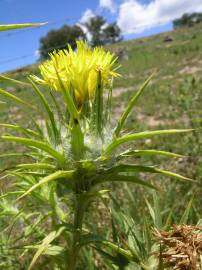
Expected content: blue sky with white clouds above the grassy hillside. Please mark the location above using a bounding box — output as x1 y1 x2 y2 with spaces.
0 0 202 72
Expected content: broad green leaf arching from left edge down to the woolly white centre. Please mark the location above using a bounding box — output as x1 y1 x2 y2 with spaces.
1 136 65 164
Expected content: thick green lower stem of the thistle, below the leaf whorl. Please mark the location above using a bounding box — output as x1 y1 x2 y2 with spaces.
67 194 87 270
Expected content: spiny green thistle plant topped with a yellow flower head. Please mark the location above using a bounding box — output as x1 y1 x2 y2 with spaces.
0 41 192 270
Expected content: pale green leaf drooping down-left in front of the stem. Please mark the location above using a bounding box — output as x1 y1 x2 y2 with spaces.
18 170 74 200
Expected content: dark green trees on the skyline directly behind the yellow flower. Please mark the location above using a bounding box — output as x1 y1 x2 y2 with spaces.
39 16 122 60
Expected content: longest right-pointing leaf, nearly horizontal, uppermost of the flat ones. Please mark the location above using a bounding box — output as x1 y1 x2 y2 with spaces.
103 129 193 156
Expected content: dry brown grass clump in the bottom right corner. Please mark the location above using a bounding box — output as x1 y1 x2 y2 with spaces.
154 225 202 270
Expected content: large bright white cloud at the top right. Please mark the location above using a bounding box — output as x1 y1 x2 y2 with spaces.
117 0 202 34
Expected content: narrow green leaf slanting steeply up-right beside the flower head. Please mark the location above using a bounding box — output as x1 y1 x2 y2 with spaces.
114 74 153 137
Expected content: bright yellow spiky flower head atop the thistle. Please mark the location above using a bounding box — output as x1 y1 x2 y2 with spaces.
34 41 119 107
